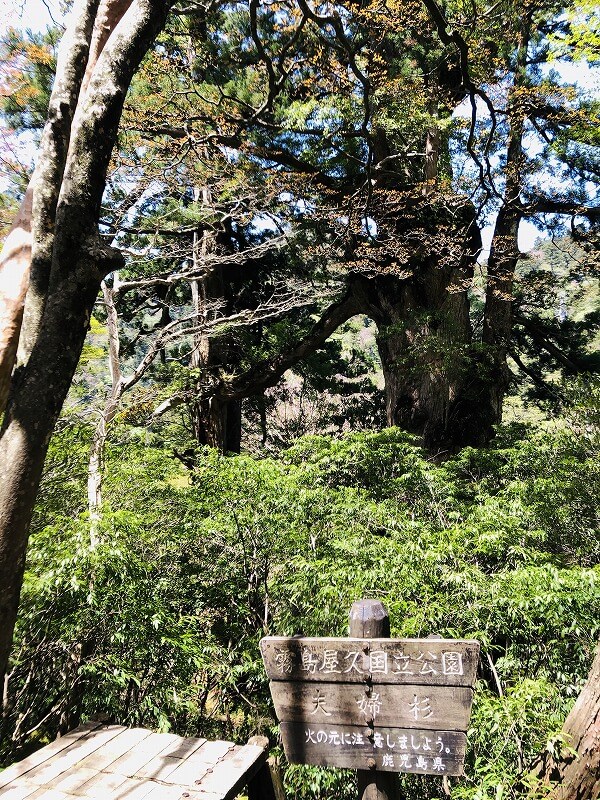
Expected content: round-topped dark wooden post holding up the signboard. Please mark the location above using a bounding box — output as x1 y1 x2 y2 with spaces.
349 600 400 800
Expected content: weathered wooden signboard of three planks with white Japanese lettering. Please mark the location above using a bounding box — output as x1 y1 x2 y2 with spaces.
260 637 479 775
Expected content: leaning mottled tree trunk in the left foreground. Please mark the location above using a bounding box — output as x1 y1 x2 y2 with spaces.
0 0 171 688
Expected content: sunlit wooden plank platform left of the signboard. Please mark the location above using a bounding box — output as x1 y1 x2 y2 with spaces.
0 723 272 800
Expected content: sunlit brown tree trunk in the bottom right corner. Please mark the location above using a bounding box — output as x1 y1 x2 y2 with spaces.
530 646 600 800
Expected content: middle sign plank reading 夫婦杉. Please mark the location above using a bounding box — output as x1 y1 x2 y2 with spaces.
270 681 473 731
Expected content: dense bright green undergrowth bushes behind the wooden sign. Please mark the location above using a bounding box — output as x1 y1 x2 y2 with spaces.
2 418 600 800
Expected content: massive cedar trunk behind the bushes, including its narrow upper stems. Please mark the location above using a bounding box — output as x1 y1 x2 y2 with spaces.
368 115 491 453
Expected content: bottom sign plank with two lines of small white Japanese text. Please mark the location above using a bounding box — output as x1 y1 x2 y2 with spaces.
281 722 467 775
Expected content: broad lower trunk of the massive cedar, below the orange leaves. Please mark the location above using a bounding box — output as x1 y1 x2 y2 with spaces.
358 266 482 452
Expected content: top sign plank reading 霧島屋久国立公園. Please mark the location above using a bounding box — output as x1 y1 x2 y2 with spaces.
260 636 479 686
